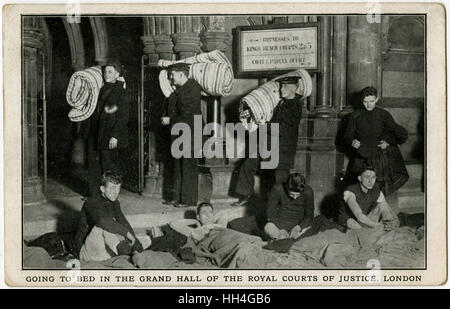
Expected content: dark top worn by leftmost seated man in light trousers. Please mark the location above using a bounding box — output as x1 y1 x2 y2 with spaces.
72 196 142 256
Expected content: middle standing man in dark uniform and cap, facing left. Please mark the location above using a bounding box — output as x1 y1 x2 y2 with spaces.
163 63 202 207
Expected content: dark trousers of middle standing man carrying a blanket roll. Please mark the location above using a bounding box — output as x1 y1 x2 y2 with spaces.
174 158 198 205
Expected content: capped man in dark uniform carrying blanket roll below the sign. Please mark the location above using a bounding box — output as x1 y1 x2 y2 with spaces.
232 76 303 206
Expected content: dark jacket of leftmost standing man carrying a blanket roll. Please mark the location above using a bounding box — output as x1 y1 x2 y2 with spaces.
97 81 130 150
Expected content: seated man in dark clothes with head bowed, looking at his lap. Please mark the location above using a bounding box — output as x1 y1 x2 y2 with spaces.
264 173 314 240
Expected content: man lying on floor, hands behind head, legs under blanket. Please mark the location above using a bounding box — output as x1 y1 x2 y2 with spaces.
169 203 265 268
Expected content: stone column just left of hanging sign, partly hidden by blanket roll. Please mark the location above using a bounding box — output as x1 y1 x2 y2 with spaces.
200 16 234 201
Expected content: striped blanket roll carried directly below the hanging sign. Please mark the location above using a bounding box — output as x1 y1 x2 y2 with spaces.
239 69 312 131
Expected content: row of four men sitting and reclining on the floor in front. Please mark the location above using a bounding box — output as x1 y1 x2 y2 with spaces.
72 162 399 261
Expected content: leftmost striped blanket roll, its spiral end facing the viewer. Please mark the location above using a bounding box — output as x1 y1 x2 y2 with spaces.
66 66 103 122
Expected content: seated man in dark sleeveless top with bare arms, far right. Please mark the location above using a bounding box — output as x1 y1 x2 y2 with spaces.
338 165 399 231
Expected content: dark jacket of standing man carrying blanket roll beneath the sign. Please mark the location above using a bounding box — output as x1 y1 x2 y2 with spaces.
270 95 303 169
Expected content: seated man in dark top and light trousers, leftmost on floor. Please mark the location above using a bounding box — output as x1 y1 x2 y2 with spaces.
73 171 143 261
